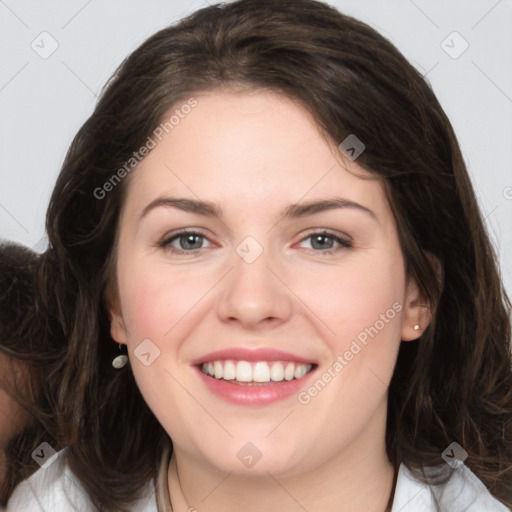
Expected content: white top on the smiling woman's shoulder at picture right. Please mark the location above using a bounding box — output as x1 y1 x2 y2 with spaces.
392 464 510 512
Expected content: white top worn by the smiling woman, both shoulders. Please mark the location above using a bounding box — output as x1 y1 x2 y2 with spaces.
7 450 511 512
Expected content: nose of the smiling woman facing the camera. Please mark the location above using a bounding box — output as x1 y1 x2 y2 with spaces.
217 241 293 330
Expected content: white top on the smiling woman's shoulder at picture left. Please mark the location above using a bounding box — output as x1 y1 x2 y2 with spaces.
6 449 157 512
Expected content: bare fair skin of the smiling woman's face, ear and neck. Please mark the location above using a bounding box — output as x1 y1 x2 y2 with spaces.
110 90 429 512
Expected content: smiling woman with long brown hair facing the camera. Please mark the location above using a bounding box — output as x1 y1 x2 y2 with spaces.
8 0 512 512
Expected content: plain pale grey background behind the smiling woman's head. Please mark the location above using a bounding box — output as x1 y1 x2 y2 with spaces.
0 0 512 295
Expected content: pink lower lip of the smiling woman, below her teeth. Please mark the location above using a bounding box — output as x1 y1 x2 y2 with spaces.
195 366 315 405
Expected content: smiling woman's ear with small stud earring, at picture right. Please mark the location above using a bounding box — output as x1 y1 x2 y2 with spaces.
401 253 443 341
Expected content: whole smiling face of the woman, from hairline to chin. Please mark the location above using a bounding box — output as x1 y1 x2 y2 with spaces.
111 91 424 475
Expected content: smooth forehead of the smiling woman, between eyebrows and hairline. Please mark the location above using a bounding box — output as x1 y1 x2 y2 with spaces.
119 90 387 222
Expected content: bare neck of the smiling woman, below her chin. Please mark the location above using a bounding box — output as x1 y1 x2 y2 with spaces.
168 400 395 512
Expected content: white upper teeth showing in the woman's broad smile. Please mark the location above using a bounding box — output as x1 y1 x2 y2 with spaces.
201 360 313 382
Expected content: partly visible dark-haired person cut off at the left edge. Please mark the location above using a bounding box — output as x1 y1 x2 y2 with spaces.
0 242 63 507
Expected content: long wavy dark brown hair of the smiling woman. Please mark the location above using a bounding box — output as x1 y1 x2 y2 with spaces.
40 0 512 511
